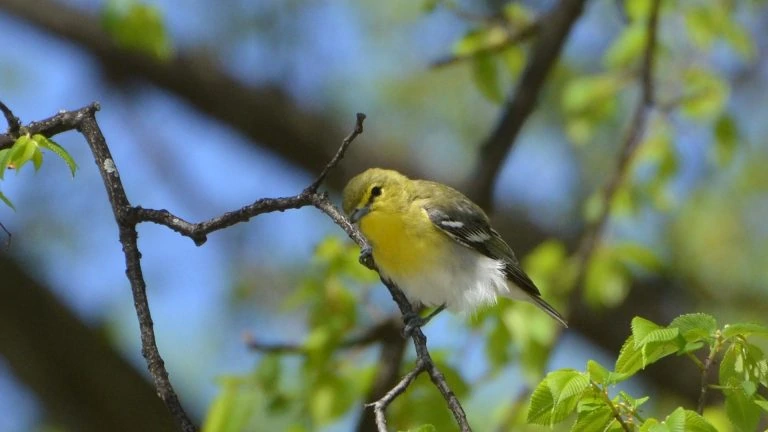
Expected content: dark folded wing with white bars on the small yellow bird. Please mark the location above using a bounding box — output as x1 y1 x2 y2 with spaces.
423 191 541 298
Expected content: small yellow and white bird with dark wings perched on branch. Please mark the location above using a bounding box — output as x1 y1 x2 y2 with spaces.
343 168 568 332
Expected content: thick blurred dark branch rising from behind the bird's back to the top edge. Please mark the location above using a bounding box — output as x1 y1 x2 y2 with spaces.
470 0 586 208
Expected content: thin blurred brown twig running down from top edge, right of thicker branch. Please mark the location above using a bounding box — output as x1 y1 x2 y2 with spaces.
574 0 660 287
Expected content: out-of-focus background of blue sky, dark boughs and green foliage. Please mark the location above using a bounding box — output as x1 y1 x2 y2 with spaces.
0 0 768 432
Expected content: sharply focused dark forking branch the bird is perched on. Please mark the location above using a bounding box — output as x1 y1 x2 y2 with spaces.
0 103 471 432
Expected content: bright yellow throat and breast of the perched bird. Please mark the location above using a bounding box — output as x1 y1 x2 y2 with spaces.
360 210 446 280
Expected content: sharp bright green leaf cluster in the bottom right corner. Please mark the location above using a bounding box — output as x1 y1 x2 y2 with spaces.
528 313 768 432
